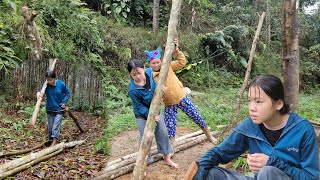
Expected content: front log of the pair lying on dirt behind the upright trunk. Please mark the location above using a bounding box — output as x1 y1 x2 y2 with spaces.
94 134 207 180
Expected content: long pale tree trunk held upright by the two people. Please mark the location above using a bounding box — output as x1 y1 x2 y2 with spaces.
131 0 181 180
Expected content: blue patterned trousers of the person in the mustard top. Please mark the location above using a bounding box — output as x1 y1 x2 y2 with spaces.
164 96 207 138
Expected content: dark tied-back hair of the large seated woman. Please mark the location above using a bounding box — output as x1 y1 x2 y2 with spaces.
248 74 289 114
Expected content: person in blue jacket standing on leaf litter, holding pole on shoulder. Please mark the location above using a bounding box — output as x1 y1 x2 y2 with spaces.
37 71 70 146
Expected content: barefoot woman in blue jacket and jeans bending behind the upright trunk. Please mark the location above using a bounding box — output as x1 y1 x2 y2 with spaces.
127 59 179 168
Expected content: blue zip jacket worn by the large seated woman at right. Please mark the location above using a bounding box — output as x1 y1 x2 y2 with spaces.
194 113 319 180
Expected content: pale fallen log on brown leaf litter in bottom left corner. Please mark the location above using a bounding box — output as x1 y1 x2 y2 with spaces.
0 141 84 176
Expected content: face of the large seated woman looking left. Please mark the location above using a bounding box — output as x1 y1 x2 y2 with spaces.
248 87 283 124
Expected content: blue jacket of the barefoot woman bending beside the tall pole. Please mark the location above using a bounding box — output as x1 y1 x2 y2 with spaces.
128 68 156 118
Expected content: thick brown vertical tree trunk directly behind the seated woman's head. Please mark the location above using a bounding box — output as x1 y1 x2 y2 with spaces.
282 0 300 111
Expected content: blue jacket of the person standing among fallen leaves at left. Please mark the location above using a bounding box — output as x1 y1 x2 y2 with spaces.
45 79 70 112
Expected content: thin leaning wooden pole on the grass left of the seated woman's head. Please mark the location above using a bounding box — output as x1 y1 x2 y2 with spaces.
221 12 266 135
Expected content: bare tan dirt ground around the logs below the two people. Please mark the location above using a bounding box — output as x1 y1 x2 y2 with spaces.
108 127 213 180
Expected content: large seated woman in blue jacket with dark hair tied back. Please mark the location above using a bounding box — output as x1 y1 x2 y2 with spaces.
194 75 319 180
